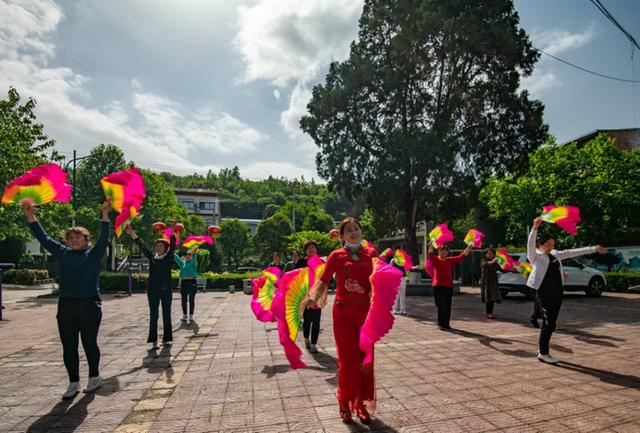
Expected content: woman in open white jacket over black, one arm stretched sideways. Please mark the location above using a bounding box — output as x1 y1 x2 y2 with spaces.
527 217 607 364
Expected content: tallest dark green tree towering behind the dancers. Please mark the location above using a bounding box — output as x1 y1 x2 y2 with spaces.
301 0 547 260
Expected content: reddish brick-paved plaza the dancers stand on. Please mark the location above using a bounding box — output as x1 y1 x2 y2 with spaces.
0 288 640 433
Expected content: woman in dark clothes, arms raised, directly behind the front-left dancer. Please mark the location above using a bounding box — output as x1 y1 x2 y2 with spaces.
127 221 176 349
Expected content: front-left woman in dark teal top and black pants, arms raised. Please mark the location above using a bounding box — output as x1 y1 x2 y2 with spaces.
20 199 111 400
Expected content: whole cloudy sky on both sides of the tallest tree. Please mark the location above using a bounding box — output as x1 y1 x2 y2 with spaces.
0 0 640 181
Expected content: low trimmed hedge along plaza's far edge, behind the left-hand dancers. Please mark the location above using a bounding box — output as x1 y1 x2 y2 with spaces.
100 272 260 293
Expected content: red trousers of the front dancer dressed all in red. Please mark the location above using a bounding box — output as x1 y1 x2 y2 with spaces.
333 303 376 414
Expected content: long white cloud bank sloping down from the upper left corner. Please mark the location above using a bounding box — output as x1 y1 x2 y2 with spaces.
0 0 266 176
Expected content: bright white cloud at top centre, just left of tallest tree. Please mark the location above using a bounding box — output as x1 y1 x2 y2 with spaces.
235 0 363 150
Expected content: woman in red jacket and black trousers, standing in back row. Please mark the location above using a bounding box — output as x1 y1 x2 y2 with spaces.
427 244 473 331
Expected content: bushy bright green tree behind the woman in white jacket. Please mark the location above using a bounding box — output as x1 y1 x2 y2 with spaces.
481 134 640 246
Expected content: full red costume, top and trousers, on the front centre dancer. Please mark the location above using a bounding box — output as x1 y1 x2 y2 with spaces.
321 247 378 413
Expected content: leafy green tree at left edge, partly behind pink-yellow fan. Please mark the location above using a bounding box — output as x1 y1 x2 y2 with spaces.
0 87 71 243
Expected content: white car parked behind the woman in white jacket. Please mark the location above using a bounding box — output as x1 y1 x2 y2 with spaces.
498 253 607 299
